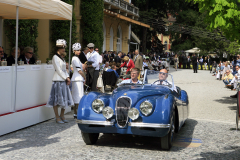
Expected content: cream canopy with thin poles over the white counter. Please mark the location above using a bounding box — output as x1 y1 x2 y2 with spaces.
0 0 72 111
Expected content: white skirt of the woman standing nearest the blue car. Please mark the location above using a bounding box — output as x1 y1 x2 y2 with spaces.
72 81 84 104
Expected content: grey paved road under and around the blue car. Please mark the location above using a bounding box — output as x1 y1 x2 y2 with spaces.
0 70 240 159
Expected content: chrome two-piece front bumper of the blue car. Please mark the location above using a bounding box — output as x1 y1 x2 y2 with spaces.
76 120 171 128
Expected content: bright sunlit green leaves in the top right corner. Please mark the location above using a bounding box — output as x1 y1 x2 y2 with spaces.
188 0 240 41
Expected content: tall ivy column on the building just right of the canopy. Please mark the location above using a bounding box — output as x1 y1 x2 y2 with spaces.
81 0 104 51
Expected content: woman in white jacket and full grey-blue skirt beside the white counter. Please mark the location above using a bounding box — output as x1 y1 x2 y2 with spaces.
46 39 74 124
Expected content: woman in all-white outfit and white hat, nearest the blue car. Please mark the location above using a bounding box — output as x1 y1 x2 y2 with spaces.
71 43 86 118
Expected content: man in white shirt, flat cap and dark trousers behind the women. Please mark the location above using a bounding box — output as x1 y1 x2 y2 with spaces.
87 43 99 91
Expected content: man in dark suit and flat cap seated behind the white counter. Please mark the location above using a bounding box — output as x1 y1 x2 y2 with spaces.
19 47 36 64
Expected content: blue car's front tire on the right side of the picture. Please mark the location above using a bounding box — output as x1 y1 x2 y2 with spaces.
161 112 175 150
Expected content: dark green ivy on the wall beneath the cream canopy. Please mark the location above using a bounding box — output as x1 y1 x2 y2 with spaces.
4 19 38 56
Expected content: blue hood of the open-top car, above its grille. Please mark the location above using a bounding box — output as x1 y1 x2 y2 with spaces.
112 85 171 105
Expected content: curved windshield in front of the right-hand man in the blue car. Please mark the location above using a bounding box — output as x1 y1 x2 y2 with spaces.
143 70 176 90
